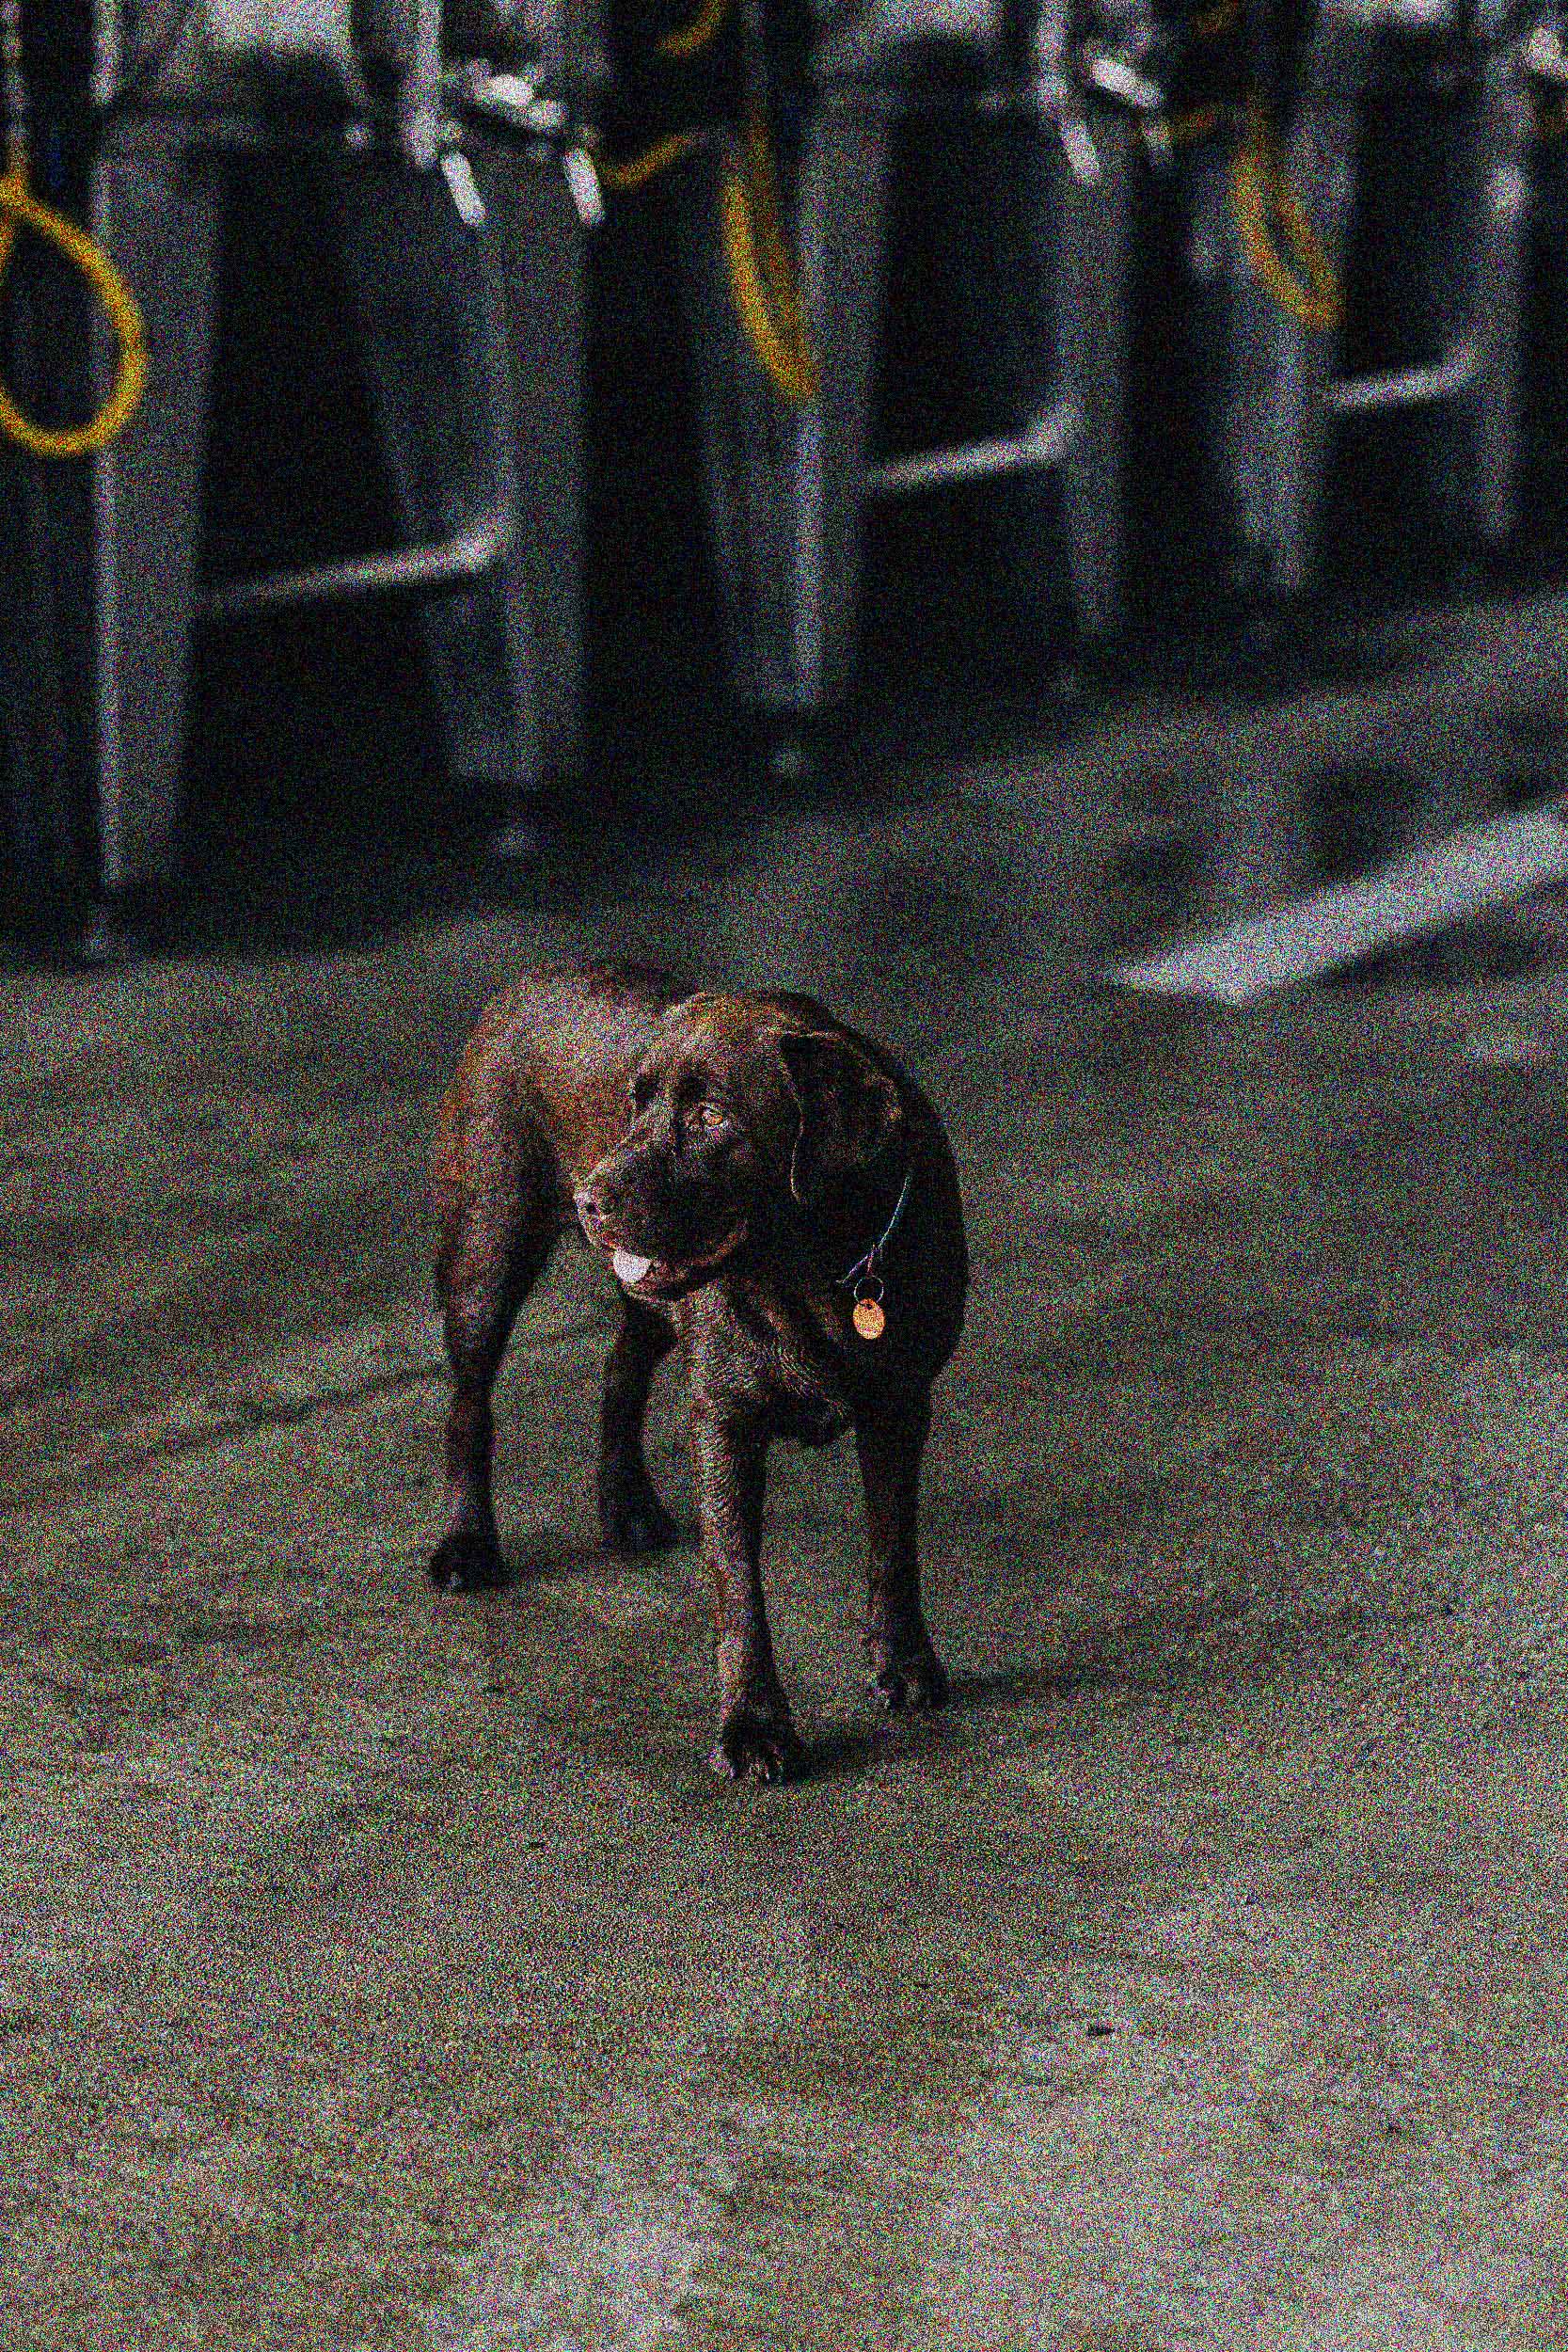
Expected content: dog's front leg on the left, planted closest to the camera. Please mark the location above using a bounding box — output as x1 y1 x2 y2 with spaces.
691 1400 801 1781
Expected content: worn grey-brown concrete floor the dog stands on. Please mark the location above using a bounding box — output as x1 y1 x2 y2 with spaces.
0 607 1568 2352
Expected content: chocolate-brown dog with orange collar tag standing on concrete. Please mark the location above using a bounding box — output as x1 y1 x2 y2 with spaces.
430 967 969 1781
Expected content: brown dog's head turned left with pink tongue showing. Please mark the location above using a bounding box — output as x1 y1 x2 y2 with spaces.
576 997 903 1298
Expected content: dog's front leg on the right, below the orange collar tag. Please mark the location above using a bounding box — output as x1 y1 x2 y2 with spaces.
856 1391 947 1712
